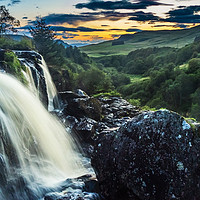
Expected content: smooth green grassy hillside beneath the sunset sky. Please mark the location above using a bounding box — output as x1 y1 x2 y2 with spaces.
81 26 200 57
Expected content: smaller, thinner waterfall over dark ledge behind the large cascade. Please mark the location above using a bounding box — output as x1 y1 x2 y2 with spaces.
14 51 59 111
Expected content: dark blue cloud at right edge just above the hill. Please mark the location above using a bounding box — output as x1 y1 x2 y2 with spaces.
162 5 200 23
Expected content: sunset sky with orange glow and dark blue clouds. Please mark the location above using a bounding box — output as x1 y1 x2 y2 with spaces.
0 0 200 46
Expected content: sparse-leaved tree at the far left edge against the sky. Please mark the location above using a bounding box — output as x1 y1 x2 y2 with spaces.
0 6 20 36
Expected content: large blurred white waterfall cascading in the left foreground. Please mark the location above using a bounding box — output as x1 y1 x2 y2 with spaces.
0 73 85 200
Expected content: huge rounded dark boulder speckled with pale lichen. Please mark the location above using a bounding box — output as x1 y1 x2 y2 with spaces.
92 110 200 200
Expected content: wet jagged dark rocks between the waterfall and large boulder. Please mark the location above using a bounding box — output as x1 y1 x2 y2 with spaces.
59 90 139 144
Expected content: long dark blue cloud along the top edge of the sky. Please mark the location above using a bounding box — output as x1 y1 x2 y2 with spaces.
75 0 169 10
